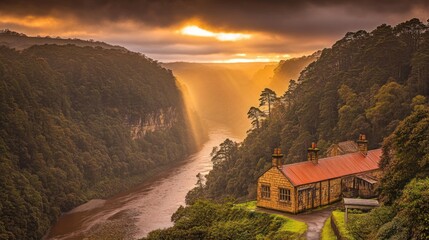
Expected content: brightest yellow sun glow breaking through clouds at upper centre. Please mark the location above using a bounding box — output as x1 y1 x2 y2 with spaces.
180 25 252 41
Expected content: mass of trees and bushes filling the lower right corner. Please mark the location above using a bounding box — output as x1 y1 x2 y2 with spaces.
349 104 429 239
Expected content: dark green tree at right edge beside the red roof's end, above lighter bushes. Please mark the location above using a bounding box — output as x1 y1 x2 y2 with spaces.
380 105 429 204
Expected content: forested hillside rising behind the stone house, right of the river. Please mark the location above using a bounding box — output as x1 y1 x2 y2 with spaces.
196 19 429 202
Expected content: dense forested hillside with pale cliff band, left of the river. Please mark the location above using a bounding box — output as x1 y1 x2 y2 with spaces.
0 45 196 239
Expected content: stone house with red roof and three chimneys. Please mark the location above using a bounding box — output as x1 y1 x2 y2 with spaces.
257 134 382 213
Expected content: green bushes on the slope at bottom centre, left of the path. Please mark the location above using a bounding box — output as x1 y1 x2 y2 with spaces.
143 201 306 240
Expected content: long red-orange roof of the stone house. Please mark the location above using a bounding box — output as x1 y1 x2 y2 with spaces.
280 149 381 186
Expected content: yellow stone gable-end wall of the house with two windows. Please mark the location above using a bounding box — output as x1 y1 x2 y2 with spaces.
256 167 296 213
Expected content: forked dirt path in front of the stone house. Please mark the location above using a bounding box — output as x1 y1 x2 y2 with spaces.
257 203 338 240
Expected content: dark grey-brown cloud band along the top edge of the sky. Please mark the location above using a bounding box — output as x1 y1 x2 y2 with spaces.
0 0 429 36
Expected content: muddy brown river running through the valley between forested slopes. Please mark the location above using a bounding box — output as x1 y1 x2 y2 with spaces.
47 128 239 239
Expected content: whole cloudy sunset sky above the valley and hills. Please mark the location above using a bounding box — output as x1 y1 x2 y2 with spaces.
0 0 429 62
